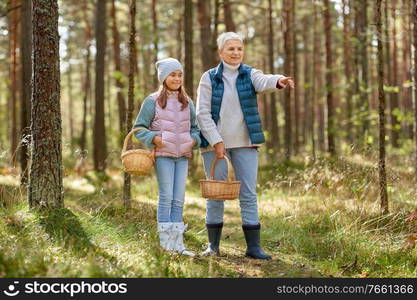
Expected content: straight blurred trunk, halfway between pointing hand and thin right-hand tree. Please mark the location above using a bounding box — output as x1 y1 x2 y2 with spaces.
323 0 336 156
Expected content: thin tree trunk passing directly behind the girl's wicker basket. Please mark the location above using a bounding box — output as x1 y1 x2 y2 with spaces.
123 0 136 208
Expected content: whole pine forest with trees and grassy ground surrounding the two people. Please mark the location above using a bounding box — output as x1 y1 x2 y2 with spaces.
0 0 417 278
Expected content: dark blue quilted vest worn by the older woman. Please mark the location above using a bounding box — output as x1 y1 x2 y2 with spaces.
200 63 265 148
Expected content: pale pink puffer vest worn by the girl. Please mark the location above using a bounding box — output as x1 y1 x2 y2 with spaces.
150 92 194 157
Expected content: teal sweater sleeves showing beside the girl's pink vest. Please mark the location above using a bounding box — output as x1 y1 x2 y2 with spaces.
132 97 201 149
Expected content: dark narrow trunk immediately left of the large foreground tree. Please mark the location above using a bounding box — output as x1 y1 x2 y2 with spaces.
20 1 32 184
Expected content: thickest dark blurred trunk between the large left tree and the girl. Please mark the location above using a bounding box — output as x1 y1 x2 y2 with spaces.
93 0 107 172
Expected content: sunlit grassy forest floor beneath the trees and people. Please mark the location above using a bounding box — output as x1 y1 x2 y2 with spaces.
0 156 417 278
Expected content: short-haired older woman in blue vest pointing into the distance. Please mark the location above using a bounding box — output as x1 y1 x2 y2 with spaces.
197 32 294 259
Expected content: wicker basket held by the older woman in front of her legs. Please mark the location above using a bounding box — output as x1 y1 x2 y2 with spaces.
200 156 240 200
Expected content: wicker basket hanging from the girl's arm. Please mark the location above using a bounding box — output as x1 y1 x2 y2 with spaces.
120 128 155 175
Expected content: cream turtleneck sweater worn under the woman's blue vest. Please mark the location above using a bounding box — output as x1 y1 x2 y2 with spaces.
197 62 283 149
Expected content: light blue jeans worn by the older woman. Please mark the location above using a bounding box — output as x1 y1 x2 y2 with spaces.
202 148 259 225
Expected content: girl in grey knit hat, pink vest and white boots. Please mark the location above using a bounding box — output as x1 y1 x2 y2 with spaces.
133 58 201 256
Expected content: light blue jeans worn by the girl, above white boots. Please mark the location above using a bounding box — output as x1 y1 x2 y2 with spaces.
155 157 188 223
